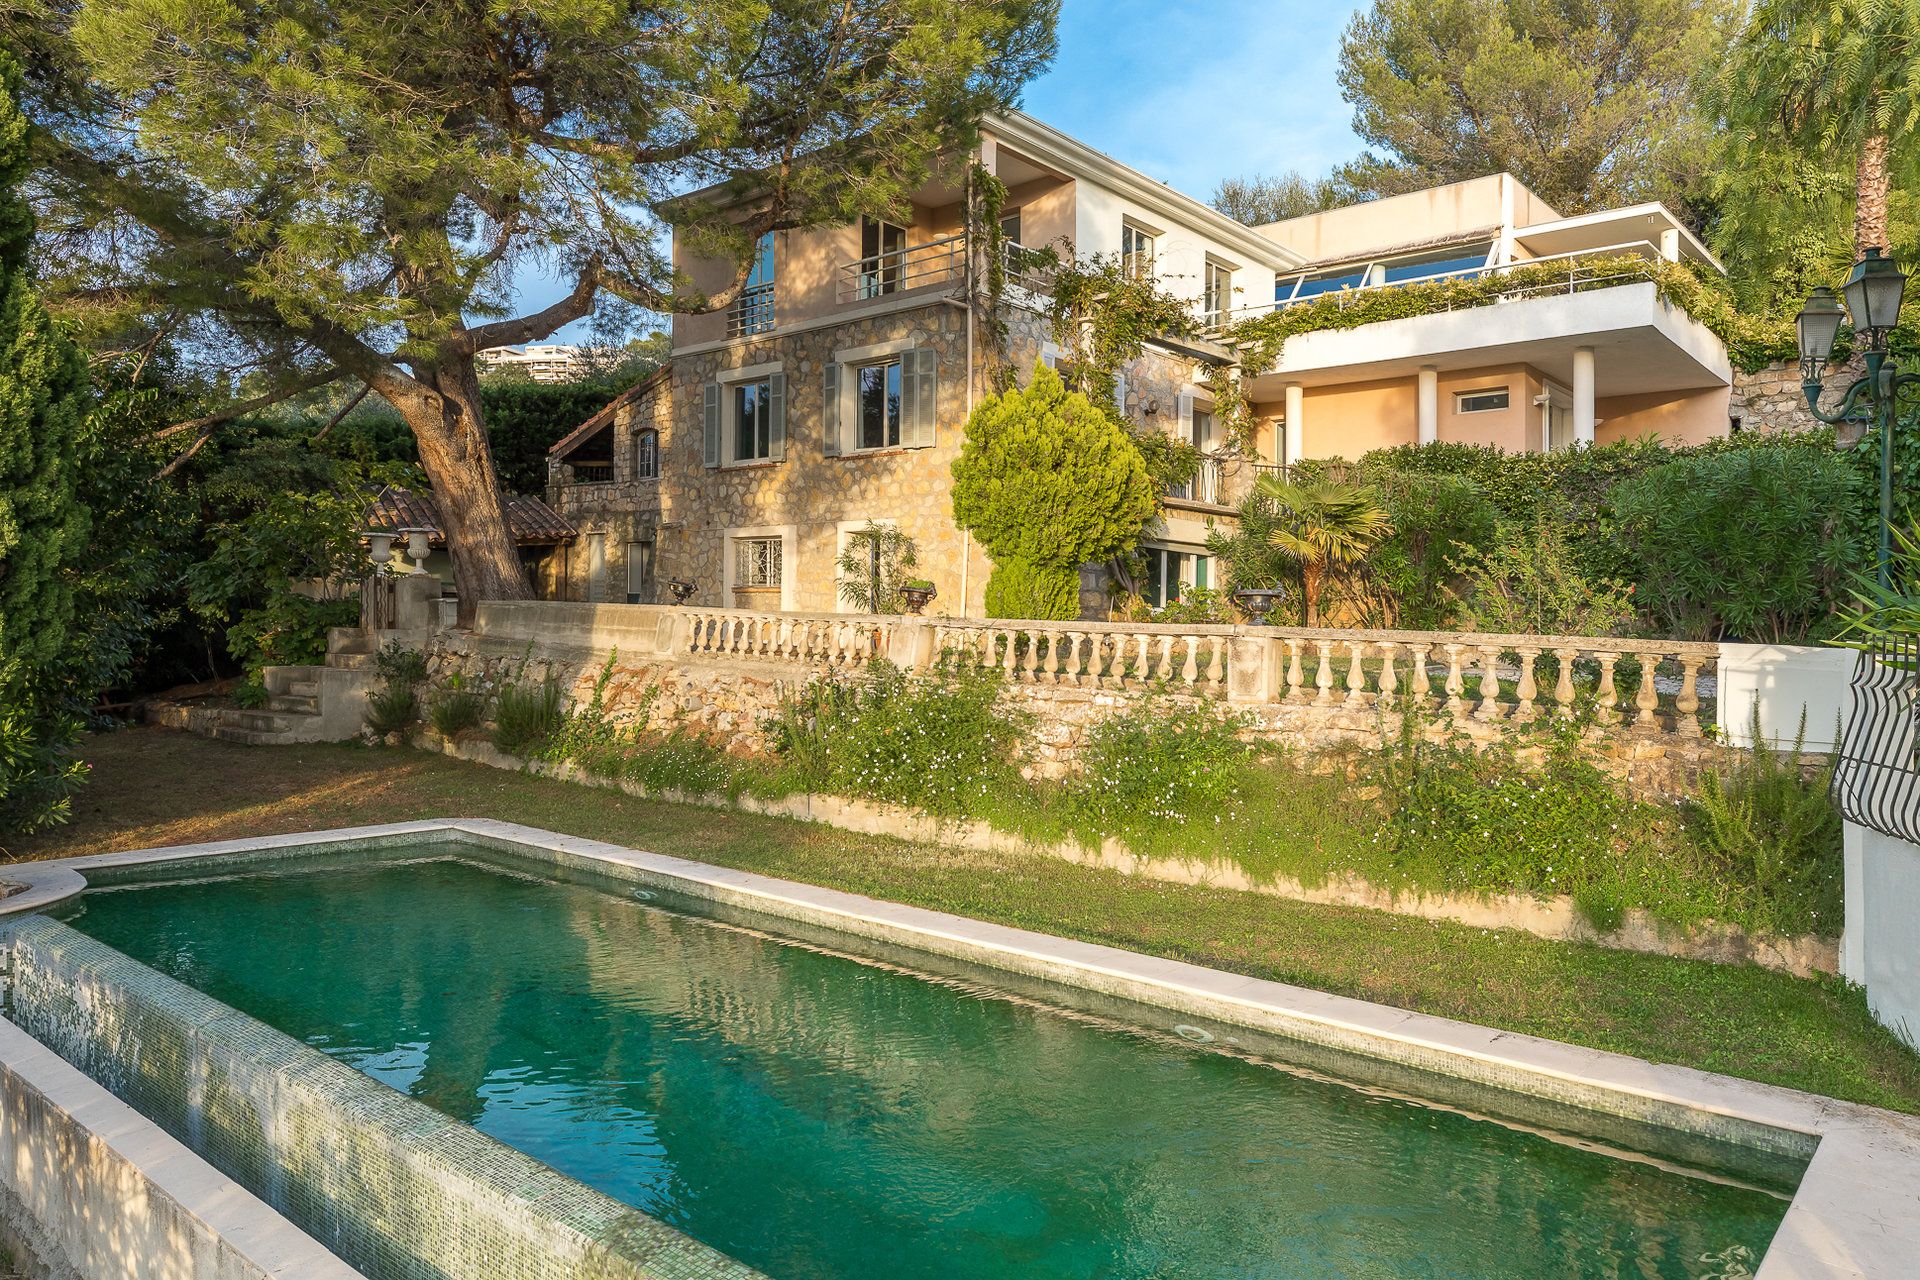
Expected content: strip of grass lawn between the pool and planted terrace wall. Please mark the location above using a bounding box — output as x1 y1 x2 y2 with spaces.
12 729 1920 1113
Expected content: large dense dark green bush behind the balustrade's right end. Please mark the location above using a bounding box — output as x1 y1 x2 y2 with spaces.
1611 445 1862 643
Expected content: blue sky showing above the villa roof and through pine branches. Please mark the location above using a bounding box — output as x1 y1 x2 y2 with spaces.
516 0 1359 342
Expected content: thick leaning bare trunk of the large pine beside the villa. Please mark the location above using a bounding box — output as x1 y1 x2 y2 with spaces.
399 359 534 626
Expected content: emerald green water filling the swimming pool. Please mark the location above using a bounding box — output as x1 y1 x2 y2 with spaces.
71 858 1786 1280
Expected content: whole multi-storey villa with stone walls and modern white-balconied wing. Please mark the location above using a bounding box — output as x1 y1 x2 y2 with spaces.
541 113 1740 616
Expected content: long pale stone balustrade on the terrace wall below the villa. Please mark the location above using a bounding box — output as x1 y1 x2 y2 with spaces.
460 601 1720 737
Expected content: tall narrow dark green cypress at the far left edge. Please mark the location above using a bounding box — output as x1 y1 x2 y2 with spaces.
0 52 88 835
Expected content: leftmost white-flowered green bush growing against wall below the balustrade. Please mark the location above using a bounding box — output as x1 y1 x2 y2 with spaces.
766 662 1029 818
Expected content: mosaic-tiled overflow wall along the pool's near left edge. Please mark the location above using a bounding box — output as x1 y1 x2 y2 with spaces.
0 915 760 1280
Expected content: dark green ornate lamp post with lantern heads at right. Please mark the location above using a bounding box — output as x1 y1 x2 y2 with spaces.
1799 249 1920 589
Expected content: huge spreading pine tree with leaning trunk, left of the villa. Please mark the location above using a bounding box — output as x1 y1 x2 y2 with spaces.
0 0 1056 608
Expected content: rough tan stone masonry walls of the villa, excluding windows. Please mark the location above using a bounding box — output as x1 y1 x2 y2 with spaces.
543 297 1231 616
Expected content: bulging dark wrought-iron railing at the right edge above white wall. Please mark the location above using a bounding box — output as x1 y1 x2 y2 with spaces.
1832 637 1920 844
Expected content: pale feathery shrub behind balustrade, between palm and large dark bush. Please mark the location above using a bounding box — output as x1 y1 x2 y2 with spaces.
1453 506 1634 635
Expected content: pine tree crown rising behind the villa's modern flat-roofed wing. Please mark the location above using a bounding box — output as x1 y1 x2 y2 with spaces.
1340 0 1732 213
